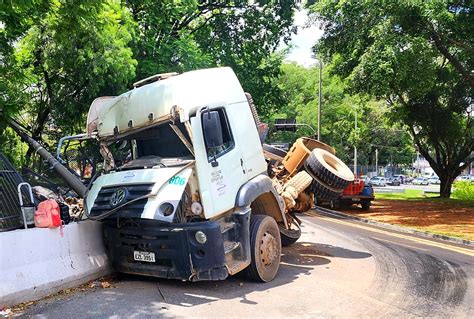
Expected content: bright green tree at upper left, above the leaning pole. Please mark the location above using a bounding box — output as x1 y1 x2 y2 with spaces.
7 1 136 162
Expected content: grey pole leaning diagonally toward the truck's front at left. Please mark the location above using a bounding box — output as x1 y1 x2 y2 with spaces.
8 120 87 197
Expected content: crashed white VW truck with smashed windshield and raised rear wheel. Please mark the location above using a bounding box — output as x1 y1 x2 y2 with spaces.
23 67 354 282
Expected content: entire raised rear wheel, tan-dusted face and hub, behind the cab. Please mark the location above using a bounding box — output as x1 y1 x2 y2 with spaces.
305 148 354 190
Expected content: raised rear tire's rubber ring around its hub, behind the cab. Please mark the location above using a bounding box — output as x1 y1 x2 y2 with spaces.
305 149 354 190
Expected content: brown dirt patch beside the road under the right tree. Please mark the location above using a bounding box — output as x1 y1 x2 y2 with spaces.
340 199 474 240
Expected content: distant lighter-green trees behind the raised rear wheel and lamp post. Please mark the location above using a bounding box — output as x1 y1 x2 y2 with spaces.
271 63 413 165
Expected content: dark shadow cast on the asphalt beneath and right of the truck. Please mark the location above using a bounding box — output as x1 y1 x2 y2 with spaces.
94 242 372 316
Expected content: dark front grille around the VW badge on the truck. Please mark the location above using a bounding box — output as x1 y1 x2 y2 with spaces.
90 183 153 217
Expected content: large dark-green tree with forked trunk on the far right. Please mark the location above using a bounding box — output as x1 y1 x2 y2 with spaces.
310 0 474 197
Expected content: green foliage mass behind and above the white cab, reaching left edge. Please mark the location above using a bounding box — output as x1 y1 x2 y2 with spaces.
0 0 295 165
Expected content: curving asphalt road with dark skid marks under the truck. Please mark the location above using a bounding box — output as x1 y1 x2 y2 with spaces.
20 211 474 318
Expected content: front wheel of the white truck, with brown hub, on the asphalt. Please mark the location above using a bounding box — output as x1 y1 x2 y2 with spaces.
244 215 281 282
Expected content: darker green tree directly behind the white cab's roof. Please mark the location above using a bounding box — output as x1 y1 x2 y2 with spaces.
126 0 296 116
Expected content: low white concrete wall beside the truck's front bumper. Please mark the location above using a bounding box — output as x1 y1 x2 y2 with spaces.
0 221 111 308
